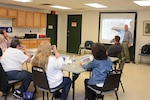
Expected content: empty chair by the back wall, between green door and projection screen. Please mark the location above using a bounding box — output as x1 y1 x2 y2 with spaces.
78 40 93 54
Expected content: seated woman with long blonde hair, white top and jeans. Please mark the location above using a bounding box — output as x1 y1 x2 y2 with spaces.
32 41 71 100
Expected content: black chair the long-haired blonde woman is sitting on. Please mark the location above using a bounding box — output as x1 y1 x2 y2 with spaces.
32 66 63 100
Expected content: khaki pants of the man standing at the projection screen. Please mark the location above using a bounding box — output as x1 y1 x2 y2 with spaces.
122 42 130 62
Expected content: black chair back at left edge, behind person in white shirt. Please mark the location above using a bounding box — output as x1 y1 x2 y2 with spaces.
0 63 8 92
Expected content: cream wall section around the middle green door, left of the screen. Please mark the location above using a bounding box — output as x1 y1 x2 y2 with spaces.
57 11 99 51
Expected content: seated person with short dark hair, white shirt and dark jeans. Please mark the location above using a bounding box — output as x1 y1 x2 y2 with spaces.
1 39 32 98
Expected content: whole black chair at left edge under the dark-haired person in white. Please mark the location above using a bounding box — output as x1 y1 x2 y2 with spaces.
0 63 22 100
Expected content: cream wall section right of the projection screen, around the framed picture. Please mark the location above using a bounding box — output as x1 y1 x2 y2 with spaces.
135 10 150 63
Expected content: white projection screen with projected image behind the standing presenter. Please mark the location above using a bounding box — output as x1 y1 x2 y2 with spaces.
99 13 135 44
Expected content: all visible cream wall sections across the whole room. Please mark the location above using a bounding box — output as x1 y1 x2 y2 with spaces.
0 4 150 63
